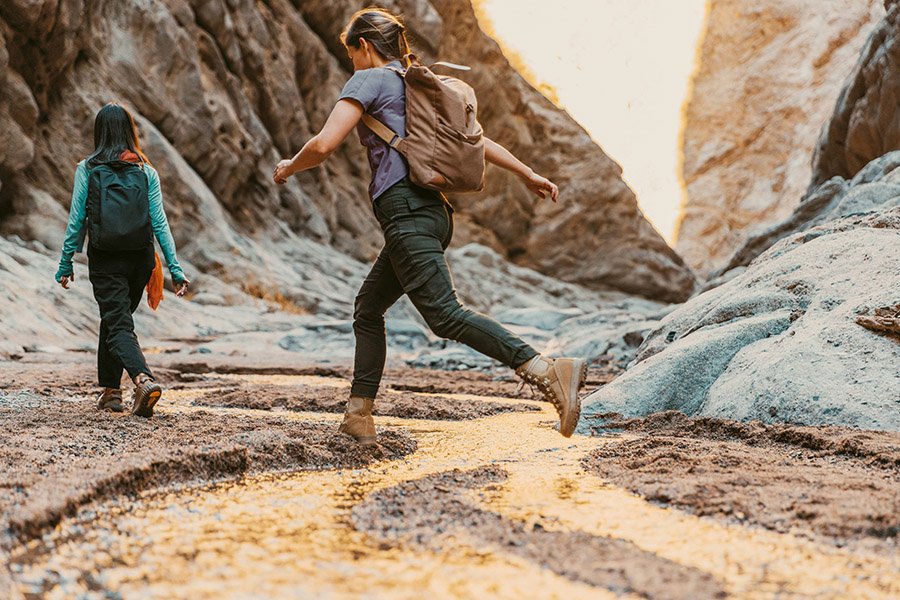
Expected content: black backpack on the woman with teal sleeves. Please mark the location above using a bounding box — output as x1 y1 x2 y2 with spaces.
85 160 153 251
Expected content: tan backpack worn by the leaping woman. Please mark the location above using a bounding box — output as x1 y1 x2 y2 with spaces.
362 54 484 193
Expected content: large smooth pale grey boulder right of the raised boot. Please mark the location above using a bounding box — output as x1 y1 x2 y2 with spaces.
580 166 900 432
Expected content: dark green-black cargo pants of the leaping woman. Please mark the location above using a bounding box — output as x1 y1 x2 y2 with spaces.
351 179 537 398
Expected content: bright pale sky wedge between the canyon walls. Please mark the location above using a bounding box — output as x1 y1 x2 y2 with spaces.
480 0 706 242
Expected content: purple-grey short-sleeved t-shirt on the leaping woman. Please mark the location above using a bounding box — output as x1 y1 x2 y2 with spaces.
339 60 409 201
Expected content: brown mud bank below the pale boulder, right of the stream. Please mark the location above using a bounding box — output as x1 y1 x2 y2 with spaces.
584 412 900 552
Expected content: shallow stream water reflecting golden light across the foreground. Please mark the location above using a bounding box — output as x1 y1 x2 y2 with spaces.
12 376 900 598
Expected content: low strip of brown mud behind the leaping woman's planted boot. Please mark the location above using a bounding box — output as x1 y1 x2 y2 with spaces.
193 384 540 421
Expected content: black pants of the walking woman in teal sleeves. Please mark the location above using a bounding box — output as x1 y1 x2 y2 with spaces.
88 246 154 388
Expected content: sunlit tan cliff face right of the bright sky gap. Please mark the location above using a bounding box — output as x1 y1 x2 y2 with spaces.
676 0 884 274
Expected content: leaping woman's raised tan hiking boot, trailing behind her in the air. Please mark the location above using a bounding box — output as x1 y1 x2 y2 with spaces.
516 355 587 437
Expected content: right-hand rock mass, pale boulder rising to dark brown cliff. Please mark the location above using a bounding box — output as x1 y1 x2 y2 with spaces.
580 0 900 432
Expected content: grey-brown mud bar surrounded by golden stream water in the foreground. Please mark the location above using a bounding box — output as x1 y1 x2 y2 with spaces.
352 467 725 600
